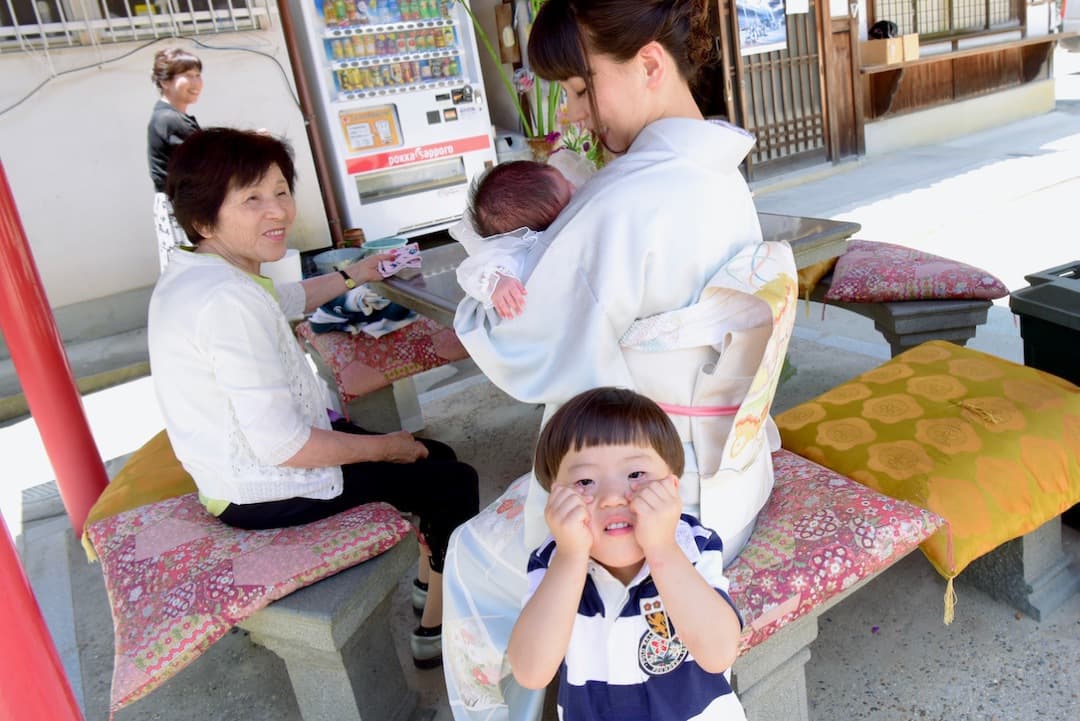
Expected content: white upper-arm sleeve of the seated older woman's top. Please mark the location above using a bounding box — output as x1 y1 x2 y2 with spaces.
198 283 311 465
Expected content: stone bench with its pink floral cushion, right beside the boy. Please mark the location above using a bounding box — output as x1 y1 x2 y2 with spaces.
726 450 943 721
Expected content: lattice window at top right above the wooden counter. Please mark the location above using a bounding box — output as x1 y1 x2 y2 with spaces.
872 0 1022 37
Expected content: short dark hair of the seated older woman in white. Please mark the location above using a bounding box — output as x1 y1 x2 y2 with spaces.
165 127 296 245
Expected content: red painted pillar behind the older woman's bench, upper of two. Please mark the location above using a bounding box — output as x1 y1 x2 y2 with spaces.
0 158 109 528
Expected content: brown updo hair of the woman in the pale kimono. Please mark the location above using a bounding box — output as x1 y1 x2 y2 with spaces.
529 0 714 84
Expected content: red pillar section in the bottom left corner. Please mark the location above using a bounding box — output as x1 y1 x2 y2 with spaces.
0 517 82 721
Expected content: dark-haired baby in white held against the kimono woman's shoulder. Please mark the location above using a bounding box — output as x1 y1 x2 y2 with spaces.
458 158 575 318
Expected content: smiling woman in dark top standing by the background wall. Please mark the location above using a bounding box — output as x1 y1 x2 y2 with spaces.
146 47 202 270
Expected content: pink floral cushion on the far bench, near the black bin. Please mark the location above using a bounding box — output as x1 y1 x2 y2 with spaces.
825 240 1009 303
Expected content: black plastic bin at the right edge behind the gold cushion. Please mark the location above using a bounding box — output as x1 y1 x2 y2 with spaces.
1009 260 1080 529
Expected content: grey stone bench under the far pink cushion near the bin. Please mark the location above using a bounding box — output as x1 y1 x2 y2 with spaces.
810 274 994 355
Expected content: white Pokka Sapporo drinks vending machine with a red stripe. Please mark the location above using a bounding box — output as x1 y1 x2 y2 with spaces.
289 0 495 239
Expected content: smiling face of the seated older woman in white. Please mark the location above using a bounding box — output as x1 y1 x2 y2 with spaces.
200 164 296 274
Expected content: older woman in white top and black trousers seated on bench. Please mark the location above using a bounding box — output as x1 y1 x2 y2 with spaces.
149 128 478 667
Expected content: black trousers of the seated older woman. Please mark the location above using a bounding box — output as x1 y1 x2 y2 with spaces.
218 421 480 573
